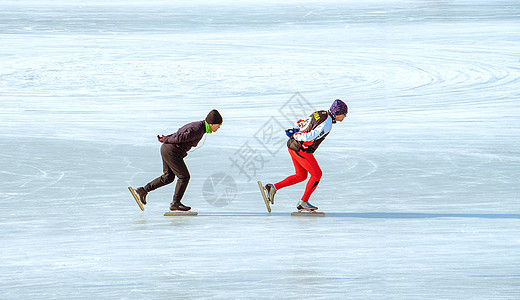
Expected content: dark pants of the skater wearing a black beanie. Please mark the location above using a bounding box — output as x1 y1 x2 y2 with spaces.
145 144 190 203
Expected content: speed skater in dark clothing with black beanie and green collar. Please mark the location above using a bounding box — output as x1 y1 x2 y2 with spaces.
131 109 222 211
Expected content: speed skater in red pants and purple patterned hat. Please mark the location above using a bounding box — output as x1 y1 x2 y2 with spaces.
265 99 348 211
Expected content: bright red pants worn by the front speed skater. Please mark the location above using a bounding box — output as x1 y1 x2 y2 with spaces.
274 149 322 202
